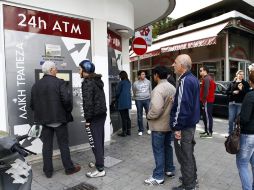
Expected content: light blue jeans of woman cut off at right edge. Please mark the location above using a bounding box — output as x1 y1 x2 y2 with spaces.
236 134 254 190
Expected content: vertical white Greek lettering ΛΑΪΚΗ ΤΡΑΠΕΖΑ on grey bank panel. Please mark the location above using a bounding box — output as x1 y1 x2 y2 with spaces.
16 42 27 119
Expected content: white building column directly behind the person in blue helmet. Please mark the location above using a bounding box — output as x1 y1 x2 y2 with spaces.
91 19 111 142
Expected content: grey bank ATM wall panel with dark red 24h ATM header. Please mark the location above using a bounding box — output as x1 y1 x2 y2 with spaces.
3 5 91 149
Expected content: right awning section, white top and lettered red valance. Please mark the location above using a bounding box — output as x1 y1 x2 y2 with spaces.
161 22 228 53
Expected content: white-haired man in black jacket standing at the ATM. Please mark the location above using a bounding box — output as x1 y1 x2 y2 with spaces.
30 61 81 178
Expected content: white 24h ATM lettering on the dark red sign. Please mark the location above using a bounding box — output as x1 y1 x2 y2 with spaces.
18 14 82 34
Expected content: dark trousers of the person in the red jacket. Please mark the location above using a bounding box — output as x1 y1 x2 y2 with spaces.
202 102 213 134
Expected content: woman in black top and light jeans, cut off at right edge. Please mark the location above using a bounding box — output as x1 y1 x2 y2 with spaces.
236 72 254 190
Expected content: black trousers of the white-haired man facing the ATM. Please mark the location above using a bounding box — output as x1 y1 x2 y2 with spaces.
41 124 74 173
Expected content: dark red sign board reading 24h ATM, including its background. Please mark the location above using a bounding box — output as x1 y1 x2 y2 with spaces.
4 5 91 40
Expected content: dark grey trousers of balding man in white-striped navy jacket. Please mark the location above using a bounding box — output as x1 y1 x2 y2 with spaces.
174 127 197 188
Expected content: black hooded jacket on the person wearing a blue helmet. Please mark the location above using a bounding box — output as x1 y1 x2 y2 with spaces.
81 73 107 122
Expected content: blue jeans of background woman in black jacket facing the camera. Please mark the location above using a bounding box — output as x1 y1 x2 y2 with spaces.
228 102 242 134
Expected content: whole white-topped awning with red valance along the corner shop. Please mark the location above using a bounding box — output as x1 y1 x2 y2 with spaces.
130 22 228 62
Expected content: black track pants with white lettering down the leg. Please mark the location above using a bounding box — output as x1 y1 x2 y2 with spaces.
86 114 107 171
